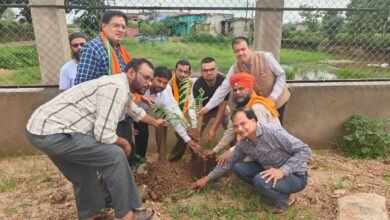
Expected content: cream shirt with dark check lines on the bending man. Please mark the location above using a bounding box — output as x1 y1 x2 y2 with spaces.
27 73 146 144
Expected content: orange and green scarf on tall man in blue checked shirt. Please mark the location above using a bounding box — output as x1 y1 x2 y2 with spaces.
99 31 141 102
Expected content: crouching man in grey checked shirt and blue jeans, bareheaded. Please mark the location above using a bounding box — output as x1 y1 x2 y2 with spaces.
192 109 311 214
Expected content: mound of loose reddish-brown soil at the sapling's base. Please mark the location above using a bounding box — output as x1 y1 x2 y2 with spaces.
135 158 216 202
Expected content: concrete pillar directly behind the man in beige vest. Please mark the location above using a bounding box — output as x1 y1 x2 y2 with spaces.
254 0 284 60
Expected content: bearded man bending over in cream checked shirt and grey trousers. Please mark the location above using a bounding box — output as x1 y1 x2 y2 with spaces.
27 58 164 219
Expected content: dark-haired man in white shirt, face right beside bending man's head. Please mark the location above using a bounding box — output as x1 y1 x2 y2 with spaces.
134 66 200 160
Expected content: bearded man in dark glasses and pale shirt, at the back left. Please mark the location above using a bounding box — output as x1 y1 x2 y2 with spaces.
59 32 87 90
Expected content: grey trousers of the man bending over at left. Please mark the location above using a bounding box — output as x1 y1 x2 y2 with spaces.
26 132 142 219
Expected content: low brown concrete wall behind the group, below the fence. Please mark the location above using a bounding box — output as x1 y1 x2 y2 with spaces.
0 82 390 156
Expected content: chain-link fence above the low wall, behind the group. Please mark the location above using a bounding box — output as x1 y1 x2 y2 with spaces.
0 0 390 86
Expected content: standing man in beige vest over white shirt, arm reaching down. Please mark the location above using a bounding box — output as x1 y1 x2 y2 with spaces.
199 37 290 124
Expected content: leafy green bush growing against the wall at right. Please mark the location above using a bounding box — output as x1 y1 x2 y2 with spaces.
338 115 390 159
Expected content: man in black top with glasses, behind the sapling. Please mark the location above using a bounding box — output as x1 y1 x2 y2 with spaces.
192 57 230 142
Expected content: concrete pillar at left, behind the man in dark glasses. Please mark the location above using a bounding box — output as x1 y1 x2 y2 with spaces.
30 0 71 85
